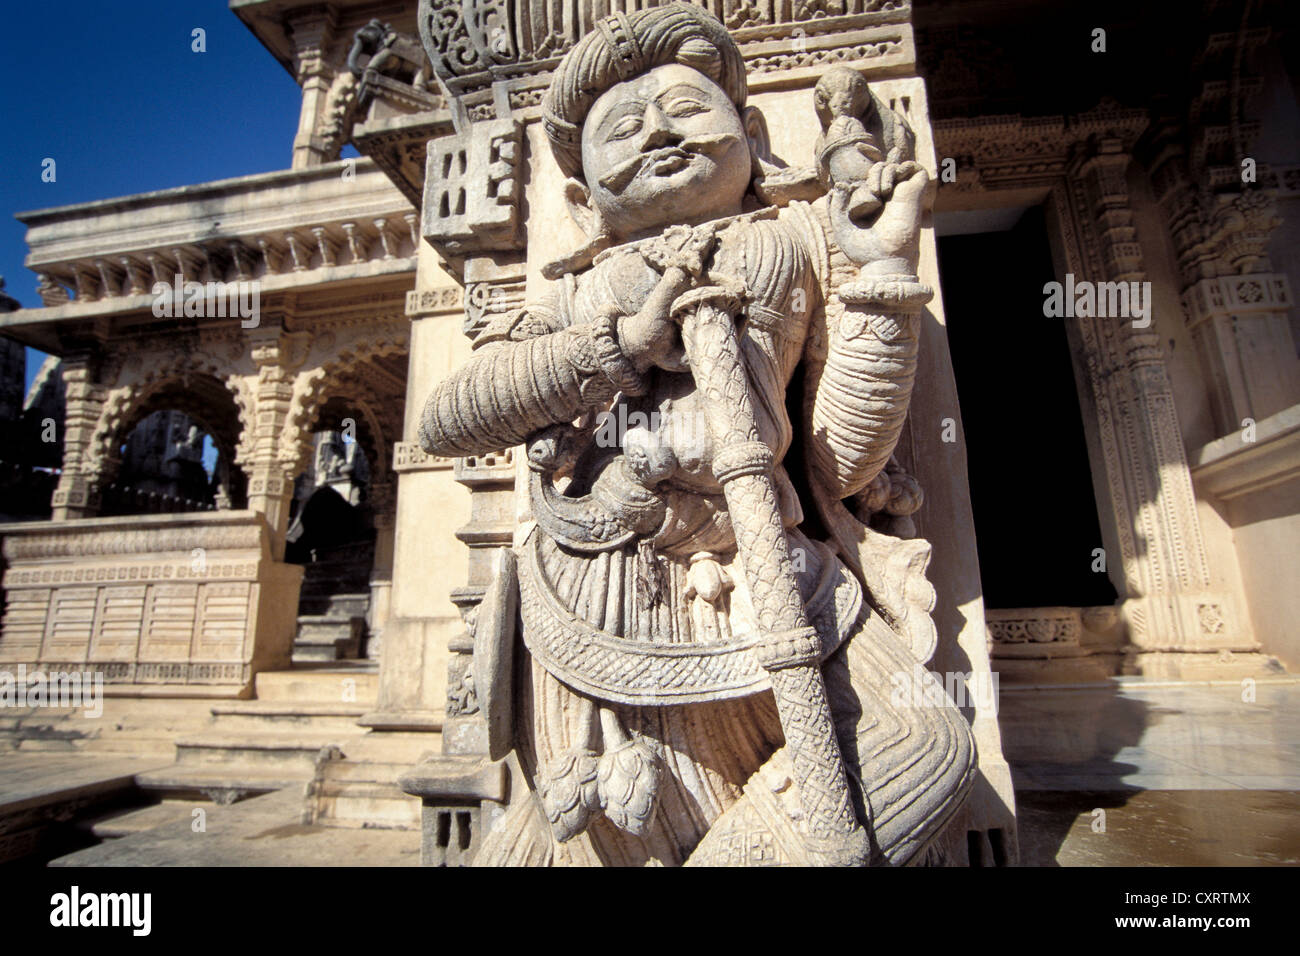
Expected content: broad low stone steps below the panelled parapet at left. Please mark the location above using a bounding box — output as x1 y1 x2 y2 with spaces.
0 661 442 861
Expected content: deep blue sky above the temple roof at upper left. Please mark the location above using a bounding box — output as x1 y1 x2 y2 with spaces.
0 0 322 395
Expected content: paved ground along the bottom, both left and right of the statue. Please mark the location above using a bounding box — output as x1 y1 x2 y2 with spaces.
0 678 1300 866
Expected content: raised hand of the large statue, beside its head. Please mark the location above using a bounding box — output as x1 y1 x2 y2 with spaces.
828 160 930 274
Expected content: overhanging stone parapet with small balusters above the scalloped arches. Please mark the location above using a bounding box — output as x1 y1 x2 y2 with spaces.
18 159 419 307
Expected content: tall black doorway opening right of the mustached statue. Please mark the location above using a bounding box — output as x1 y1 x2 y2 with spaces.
939 207 1117 607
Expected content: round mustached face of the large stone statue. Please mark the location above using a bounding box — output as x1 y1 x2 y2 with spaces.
582 64 750 239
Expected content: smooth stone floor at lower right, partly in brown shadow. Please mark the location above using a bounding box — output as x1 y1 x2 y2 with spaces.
998 678 1300 866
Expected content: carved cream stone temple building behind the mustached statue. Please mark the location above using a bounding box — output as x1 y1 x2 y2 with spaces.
0 0 1300 865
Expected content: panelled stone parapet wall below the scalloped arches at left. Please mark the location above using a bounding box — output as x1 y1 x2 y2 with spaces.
0 511 303 695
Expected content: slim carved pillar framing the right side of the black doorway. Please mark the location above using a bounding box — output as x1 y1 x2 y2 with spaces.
1058 139 1255 652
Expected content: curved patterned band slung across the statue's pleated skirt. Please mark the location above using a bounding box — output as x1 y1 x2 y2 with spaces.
519 531 863 706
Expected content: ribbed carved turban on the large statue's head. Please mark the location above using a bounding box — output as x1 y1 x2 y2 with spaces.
542 3 746 178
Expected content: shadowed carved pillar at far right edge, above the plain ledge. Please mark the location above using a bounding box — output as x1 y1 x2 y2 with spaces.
1148 3 1300 436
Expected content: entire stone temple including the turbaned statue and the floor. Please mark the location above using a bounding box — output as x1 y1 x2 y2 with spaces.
0 0 1300 866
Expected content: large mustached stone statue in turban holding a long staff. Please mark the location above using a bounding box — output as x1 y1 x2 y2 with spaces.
420 4 975 865
